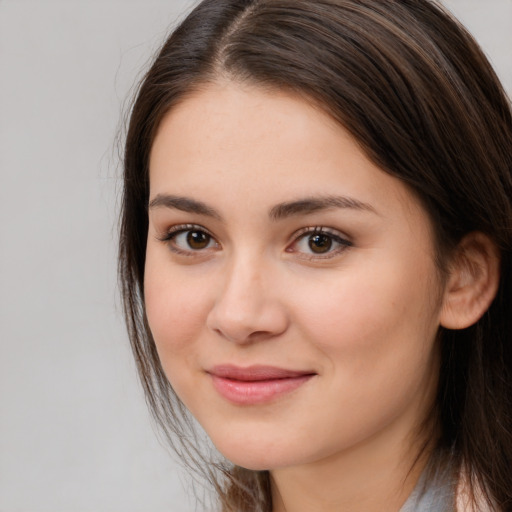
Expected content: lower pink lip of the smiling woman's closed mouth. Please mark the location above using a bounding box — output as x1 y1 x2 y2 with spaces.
211 375 313 405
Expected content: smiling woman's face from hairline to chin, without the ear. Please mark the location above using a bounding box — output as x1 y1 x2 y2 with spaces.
145 82 442 469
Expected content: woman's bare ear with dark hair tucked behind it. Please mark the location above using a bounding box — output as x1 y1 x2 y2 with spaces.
440 232 500 329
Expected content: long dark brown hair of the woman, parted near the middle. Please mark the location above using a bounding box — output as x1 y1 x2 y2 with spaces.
119 0 512 512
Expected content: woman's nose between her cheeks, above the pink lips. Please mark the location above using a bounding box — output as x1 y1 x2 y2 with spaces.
207 257 288 344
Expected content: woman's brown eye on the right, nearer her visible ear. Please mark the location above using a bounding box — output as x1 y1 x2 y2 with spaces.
287 227 352 259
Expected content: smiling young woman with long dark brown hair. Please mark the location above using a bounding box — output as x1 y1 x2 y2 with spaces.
120 0 512 512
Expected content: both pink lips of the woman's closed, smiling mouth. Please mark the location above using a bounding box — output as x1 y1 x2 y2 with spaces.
207 365 316 405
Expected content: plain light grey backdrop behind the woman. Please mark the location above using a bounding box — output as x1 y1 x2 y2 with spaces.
0 0 512 512
